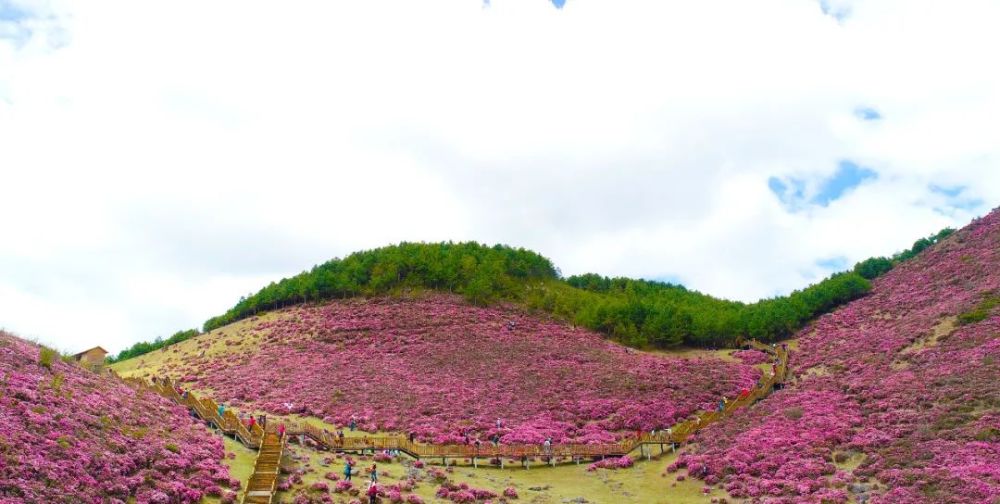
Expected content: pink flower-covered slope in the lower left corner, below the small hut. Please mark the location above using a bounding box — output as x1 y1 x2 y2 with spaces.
0 332 232 504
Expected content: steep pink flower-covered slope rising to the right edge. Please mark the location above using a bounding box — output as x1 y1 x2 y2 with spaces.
670 211 1000 504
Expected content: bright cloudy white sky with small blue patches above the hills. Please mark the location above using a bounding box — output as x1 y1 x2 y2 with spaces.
0 0 1000 352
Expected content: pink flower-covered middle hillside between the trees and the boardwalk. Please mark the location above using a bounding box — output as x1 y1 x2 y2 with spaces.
143 294 760 443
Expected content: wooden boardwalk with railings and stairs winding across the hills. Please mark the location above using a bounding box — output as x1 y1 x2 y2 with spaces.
115 341 788 504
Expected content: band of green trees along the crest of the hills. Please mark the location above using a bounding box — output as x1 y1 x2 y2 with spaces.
112 228 954 362
